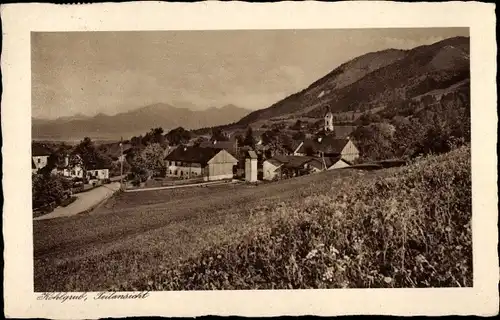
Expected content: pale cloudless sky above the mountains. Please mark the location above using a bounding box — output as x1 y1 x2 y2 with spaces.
31 28 469 119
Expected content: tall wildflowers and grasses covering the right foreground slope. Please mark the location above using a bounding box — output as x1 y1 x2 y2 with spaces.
121 147 472 290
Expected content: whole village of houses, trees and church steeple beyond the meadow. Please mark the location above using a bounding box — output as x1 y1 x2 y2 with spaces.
32 111 376 218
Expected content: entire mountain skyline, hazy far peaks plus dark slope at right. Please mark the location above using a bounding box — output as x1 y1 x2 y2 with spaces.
32 37 470 140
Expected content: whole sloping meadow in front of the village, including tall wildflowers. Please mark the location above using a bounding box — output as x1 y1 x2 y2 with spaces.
34 149 472 291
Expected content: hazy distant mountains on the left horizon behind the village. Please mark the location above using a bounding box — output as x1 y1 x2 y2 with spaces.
32 103 250 140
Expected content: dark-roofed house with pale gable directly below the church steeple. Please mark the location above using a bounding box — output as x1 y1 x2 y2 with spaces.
293 136 359 163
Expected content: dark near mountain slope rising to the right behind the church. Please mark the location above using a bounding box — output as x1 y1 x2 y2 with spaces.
238 37 470 126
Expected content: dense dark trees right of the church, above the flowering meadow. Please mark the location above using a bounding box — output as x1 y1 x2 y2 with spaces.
352 93 470 160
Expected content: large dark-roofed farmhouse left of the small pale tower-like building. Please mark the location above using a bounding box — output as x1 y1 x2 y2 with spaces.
165 146 238 181
